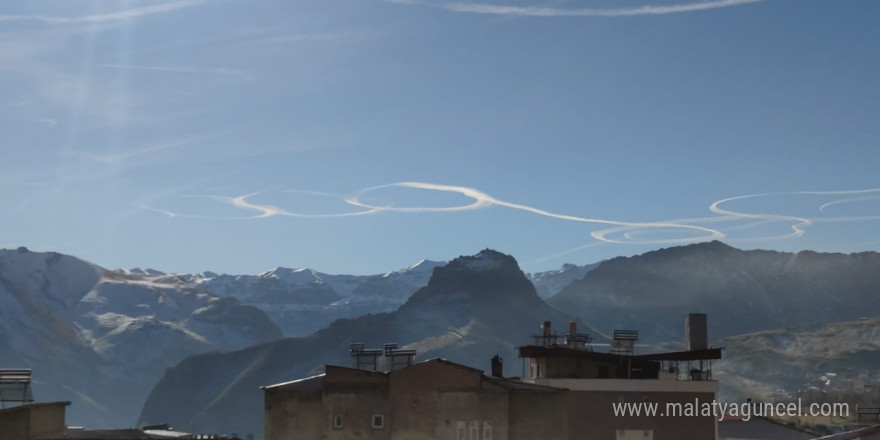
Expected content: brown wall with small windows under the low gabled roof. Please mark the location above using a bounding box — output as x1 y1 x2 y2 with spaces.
265 362 510 440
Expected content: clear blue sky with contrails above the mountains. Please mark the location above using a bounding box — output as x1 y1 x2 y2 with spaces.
0 0 880 273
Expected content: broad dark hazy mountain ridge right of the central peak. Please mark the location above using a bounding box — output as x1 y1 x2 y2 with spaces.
548 242 880 343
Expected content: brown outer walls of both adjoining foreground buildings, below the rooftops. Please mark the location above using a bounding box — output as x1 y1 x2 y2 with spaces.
266 361 718 440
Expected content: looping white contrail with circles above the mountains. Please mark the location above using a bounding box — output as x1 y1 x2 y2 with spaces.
143 182 880 249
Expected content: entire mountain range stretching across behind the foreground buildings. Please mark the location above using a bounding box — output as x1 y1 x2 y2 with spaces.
0 242 880 433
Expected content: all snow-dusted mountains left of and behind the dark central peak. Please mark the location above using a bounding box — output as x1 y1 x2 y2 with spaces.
0 248 592 427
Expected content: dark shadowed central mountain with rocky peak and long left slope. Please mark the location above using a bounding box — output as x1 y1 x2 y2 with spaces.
141 250 570 435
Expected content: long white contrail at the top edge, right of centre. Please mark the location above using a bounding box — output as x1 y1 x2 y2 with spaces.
385 0 767 17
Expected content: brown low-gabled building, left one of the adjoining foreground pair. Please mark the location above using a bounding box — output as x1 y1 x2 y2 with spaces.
264 359 568 440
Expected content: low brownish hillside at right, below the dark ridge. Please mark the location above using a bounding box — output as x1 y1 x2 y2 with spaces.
714 317 880 403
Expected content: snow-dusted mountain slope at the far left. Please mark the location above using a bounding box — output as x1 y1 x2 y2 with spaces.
0 248 281 427
